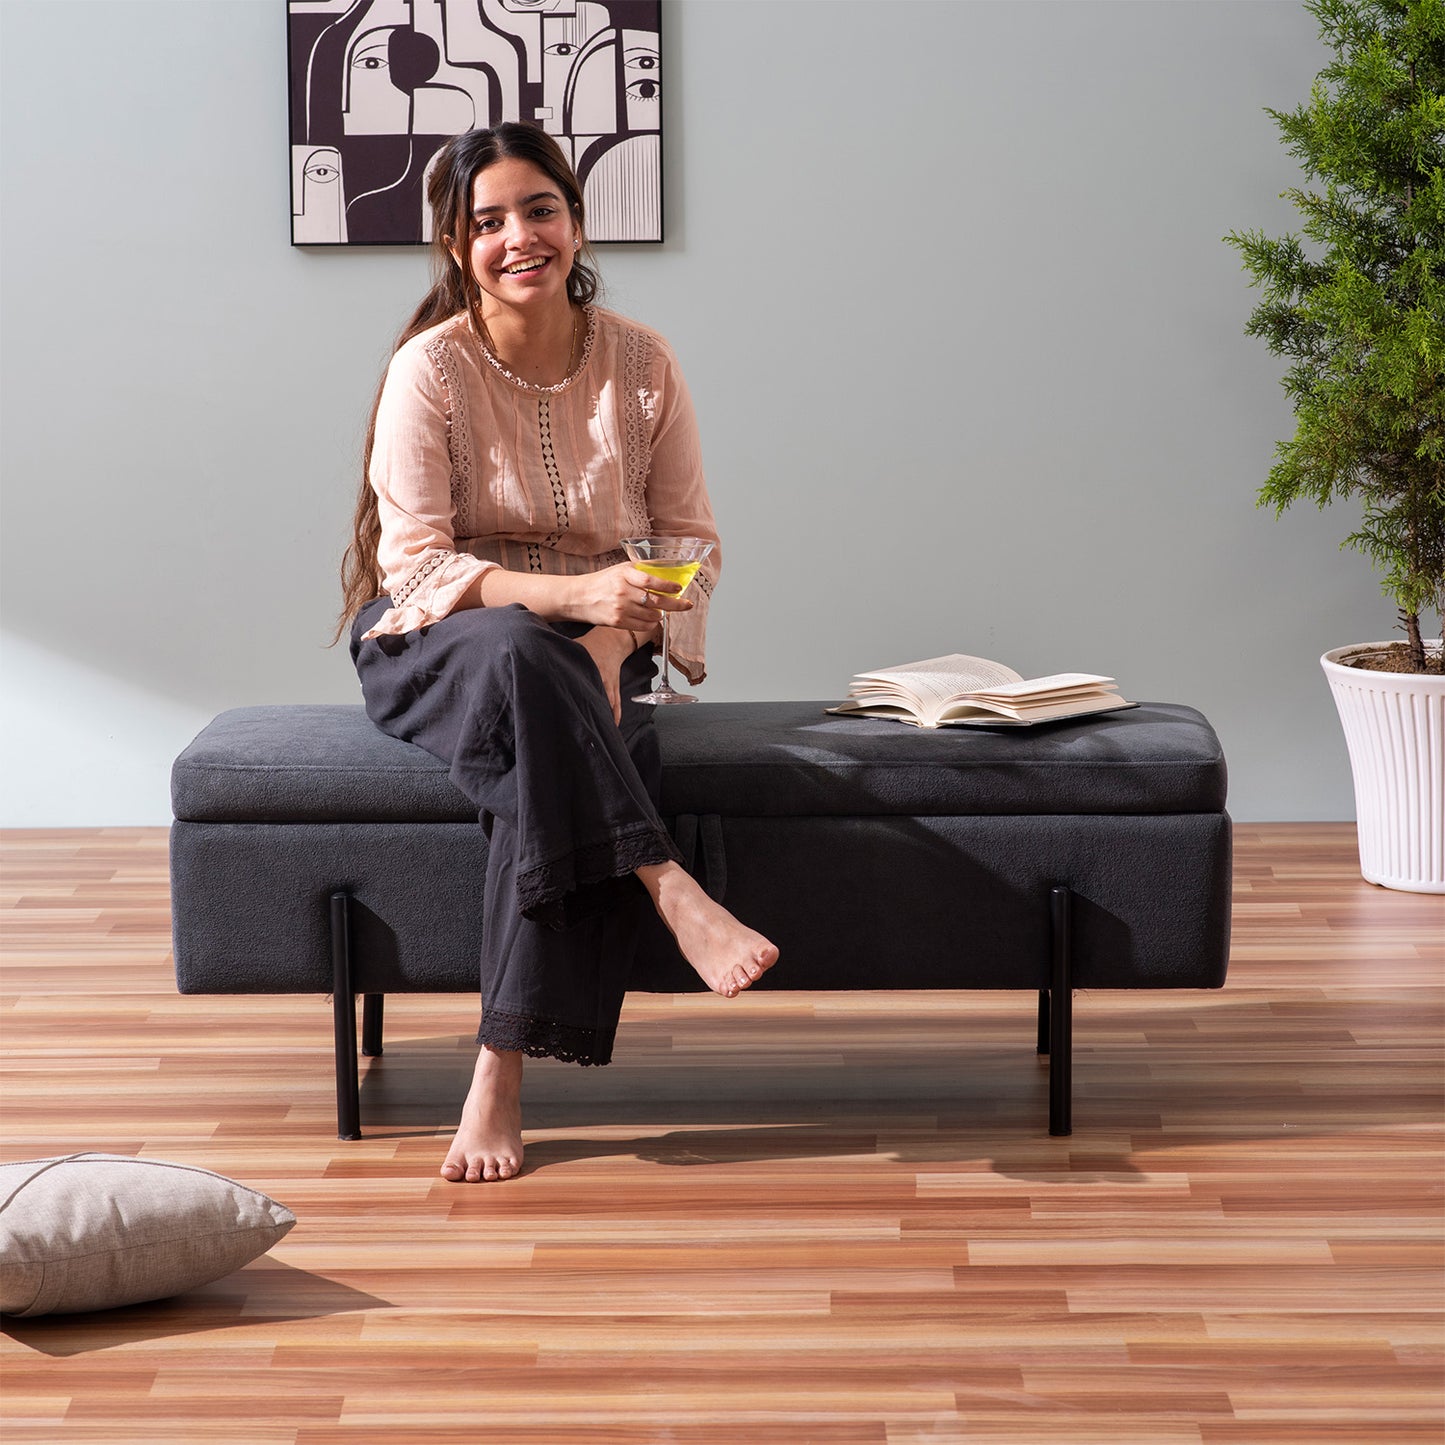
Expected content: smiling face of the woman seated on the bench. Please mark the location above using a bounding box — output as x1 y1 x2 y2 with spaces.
452 156 581 315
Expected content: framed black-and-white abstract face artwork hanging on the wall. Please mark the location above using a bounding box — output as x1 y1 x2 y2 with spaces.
286 0 662 246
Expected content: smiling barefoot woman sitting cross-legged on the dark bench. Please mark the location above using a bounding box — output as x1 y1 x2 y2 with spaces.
342 124 777 1182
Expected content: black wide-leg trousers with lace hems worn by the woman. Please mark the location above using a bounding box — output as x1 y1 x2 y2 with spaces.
351 597 679 1064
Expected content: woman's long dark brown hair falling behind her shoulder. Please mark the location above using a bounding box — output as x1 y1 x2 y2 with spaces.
332 120 601 642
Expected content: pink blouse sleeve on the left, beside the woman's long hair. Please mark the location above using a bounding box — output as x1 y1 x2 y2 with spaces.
366 338 496 637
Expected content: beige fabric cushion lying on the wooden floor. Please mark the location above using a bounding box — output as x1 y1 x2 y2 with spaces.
0 1153 296 1316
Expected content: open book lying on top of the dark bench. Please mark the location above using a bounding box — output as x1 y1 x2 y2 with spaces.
827 652 1139 727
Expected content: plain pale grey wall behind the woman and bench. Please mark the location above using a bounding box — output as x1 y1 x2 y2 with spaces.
0 0 1393 825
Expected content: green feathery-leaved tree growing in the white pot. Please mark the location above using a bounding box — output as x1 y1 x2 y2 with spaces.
1227 0 1445 672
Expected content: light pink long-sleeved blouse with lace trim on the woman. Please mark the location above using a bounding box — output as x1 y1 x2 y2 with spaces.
366 306 721 682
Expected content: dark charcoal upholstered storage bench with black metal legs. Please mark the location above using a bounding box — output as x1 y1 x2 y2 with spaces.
171 702 1230 1139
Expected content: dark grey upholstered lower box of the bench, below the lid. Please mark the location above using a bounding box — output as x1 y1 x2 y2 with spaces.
171 814 1230 994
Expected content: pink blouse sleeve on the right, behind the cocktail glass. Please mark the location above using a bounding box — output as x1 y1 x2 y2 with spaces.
646 342 723 683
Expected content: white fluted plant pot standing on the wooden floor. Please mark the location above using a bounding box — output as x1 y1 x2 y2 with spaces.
1319 642 1445 893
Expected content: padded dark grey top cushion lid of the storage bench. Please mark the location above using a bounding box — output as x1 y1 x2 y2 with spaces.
172 702 1225 824
